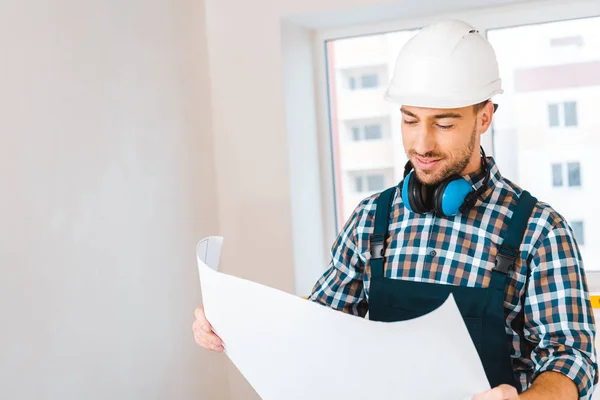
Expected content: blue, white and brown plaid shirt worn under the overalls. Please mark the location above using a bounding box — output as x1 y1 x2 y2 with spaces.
309 157 598 399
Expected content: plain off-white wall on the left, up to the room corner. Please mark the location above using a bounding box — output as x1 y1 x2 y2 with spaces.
0 0 229 400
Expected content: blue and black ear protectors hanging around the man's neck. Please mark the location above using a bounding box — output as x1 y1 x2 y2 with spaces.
400 148 490 217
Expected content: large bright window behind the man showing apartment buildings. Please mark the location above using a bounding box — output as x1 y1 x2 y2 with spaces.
324 12 600 275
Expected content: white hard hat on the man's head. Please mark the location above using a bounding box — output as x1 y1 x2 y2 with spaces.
384 20 504 108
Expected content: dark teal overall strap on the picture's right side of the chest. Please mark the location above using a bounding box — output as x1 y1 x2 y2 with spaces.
492 190 537 275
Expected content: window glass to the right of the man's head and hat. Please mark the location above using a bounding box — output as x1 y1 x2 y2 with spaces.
487 17 600 270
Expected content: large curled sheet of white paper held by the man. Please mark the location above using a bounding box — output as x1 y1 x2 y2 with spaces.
196 237 490 400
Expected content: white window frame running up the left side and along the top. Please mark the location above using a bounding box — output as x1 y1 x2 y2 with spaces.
313 0 600 292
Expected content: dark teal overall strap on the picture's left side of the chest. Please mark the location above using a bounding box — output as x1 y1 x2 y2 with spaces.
370 186 397 277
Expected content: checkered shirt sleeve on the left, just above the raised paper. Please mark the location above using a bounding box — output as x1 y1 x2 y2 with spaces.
308 202 368 317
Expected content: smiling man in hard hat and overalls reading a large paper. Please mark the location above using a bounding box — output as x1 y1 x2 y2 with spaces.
194 20 598 400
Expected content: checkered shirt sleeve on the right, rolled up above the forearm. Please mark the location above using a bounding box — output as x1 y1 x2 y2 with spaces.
524 218 598 399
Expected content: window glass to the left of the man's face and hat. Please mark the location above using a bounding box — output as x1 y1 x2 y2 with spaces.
326 30 417 225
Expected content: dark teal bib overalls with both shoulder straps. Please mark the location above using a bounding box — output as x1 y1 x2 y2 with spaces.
369 187 537 389
